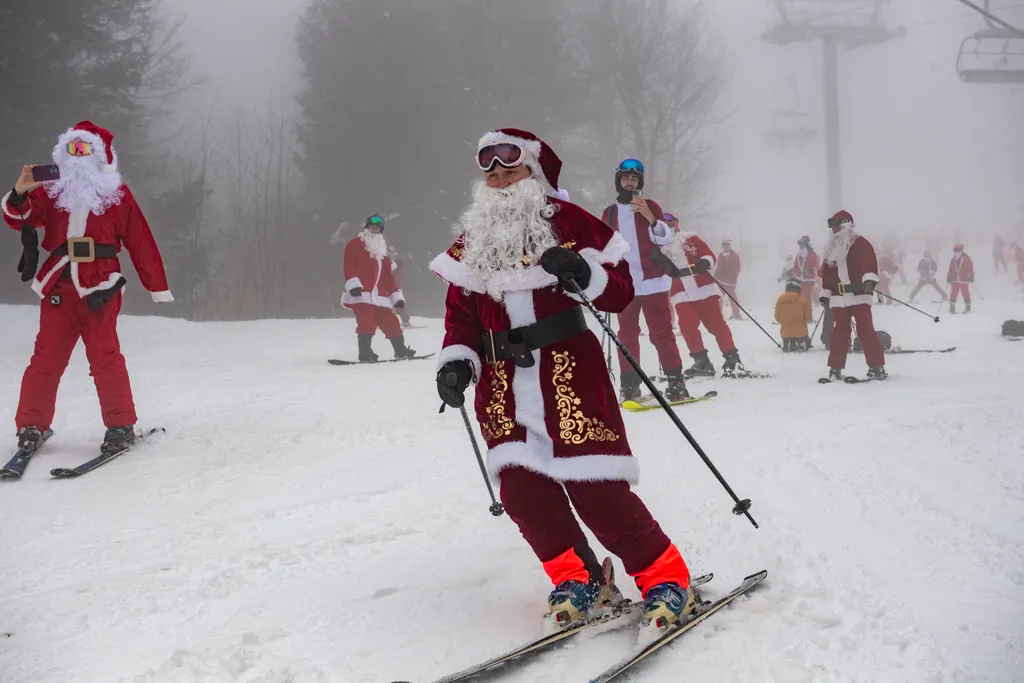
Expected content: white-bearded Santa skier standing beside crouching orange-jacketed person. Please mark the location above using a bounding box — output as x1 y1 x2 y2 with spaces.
819 211 887 380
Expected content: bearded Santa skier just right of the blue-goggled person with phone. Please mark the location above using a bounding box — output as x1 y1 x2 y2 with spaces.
651 225 746 378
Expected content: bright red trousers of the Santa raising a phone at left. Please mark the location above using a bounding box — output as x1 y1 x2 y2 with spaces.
14 279 137 429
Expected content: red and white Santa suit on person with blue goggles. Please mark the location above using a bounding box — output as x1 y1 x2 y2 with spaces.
602 200 683 374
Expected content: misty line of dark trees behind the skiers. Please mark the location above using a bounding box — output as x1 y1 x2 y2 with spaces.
0 0 724 319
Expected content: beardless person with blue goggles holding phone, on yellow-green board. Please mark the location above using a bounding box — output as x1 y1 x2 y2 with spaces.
601 159 690 401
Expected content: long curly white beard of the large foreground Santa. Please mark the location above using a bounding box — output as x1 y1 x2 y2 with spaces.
455 178 559 301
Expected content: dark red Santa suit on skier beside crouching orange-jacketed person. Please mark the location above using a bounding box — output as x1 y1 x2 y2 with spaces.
821 221 886 370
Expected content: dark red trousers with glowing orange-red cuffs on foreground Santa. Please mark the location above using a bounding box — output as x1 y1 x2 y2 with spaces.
500 467 690 594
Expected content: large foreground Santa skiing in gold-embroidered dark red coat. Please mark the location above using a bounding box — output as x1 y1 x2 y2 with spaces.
430 128 694 628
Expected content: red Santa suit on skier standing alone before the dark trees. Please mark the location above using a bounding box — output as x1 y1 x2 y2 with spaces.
341 232 406 339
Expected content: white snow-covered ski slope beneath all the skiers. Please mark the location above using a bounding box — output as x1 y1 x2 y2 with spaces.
0 294 1024 683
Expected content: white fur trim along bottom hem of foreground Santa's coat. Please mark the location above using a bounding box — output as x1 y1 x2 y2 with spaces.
487 441 640 484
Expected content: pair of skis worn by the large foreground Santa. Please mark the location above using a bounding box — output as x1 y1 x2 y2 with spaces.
393 570 768 683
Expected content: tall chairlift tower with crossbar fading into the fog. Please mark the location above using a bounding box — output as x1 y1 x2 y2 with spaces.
762 0 906 214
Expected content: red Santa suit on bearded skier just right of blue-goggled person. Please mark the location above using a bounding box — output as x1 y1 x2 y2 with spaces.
662 230 736 357
